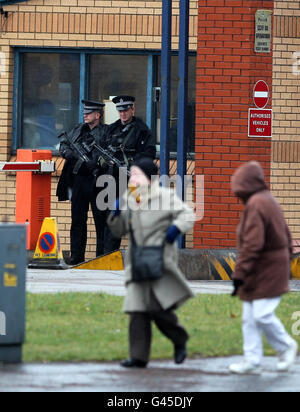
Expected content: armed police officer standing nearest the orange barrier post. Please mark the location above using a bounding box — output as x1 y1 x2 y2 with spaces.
57 100 108 265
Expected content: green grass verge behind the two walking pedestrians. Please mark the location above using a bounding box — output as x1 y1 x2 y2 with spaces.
23 293 300 362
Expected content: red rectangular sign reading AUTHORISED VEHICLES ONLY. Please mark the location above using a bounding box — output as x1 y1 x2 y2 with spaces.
248 109 272 137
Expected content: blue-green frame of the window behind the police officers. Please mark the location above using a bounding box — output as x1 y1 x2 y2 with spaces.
11 46 196 158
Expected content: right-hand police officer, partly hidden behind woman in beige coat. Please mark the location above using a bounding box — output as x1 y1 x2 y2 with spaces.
104 95 156 253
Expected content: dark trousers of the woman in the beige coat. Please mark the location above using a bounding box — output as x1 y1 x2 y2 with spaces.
129 310 189 362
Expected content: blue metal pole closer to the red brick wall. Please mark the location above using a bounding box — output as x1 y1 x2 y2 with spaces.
177 0 190 248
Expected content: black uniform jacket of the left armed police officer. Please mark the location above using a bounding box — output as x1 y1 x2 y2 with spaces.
56 123 108 201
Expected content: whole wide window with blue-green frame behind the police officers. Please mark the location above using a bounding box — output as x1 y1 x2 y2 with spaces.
13 48 196 155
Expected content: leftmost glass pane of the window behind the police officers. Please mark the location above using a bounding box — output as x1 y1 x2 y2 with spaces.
19 53 80 149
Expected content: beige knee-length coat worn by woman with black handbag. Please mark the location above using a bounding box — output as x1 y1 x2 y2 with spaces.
108 183 195 313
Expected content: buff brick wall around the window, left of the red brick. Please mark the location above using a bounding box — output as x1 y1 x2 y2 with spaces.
0 0 198 257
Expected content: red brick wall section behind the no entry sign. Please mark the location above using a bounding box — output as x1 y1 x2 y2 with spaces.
194 0 273 249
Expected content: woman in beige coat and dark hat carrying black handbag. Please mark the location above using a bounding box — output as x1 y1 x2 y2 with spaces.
108 158 195 368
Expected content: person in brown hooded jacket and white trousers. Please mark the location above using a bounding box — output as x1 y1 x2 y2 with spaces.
229 162 298 374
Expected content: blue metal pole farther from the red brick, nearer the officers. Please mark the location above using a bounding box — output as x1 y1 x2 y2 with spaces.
160 0 172 182
